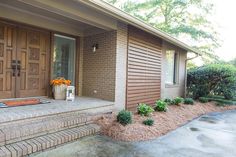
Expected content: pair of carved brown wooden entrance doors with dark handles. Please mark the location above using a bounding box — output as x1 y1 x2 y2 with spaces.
0 22 50 99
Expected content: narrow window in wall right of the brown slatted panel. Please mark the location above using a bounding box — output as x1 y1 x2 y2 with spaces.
165 50 178 84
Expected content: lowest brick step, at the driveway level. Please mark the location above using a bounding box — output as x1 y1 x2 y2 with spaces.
0 124 100 157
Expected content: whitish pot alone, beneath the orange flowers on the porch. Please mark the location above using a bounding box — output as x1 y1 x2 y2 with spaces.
53 84 67 100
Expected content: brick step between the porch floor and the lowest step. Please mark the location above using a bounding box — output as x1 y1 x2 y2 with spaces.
0 113 96 146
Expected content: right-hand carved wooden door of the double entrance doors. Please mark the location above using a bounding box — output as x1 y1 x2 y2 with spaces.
16 28 50 97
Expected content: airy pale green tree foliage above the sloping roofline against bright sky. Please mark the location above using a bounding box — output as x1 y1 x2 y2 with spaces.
104 0 220 59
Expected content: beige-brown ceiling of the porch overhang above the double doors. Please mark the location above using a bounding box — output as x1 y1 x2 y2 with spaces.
0 0 117 36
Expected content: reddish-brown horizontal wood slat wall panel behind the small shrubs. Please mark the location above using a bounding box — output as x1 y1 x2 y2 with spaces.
126 26 162 112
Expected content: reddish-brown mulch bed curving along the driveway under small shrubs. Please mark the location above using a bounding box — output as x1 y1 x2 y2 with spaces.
97 102 236 141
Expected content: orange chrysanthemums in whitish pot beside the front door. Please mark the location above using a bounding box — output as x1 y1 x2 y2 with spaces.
51 77 71 100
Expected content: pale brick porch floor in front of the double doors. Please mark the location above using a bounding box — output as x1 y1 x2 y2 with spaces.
0 97 114 123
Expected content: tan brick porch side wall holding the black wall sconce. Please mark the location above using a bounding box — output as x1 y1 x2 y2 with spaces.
82 31 116 101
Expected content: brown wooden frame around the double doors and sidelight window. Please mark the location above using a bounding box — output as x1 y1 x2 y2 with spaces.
0 17 81 97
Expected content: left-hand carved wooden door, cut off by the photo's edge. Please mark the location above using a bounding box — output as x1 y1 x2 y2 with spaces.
0 23 16 99
